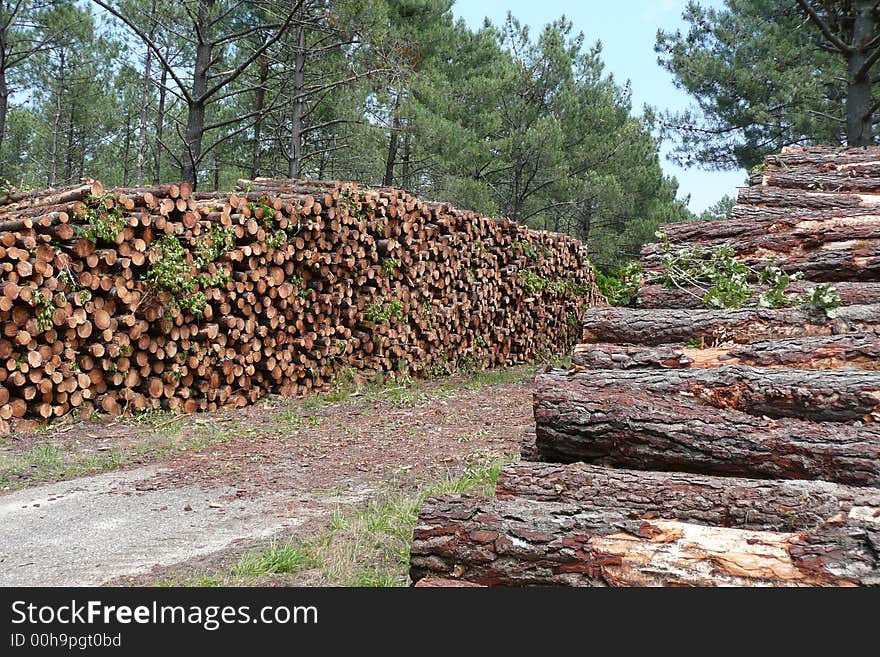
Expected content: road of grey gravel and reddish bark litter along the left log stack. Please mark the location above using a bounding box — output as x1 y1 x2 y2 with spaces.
0 368 534 586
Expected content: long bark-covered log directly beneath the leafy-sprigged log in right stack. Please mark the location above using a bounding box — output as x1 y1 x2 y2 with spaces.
583 305 880 345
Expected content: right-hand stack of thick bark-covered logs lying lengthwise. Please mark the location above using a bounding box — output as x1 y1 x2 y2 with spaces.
411 148 880 586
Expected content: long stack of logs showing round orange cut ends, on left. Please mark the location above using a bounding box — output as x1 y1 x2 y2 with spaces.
0 179 602 431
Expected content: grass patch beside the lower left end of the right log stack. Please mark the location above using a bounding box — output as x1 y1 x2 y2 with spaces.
161 456 513 587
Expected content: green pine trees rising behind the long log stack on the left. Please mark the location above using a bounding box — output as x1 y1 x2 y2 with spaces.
0 0 691 266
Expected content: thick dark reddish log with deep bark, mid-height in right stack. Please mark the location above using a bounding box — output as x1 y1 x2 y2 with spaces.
534 371 880 487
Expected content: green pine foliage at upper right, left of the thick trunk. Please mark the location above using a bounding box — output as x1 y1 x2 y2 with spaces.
655 0 852 169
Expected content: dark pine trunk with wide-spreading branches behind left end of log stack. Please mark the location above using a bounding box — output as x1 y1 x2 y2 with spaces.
180 0 214 188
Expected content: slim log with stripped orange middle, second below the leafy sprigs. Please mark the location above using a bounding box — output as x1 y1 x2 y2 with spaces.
572 332 880 370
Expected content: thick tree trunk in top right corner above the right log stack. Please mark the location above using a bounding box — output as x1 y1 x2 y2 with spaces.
846 0 877 146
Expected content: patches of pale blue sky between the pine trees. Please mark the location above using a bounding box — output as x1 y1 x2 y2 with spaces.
453 0 746 212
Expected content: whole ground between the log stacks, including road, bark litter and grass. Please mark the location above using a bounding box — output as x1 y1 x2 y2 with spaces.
0 366 552 586
